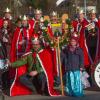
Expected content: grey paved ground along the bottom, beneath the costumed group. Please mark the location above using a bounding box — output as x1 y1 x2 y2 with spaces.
0 89 100 100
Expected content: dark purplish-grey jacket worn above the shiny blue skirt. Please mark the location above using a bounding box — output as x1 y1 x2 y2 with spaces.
61 46 84 71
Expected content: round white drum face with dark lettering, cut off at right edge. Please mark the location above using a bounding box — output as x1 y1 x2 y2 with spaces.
94 62 100 88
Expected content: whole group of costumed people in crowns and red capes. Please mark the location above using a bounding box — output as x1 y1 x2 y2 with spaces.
0 8 100 96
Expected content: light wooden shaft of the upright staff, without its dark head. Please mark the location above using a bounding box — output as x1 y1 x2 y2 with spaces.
57 37 64 96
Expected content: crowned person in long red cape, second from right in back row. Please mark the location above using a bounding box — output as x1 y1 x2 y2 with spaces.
72 10 90 68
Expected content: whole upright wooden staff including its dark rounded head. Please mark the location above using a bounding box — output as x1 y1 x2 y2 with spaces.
55 29 64 95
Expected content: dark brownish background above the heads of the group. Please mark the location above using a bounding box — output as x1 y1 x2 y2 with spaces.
0 0 100 17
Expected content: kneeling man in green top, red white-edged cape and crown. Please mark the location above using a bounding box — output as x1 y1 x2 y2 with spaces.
10 34 59 96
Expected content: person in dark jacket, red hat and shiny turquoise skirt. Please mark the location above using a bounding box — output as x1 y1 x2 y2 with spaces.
62 33 84 97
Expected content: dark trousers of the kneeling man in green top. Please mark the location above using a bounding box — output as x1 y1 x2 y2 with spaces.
19 73 47 94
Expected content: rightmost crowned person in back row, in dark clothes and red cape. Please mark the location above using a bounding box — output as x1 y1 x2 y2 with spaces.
85 10 100 65
